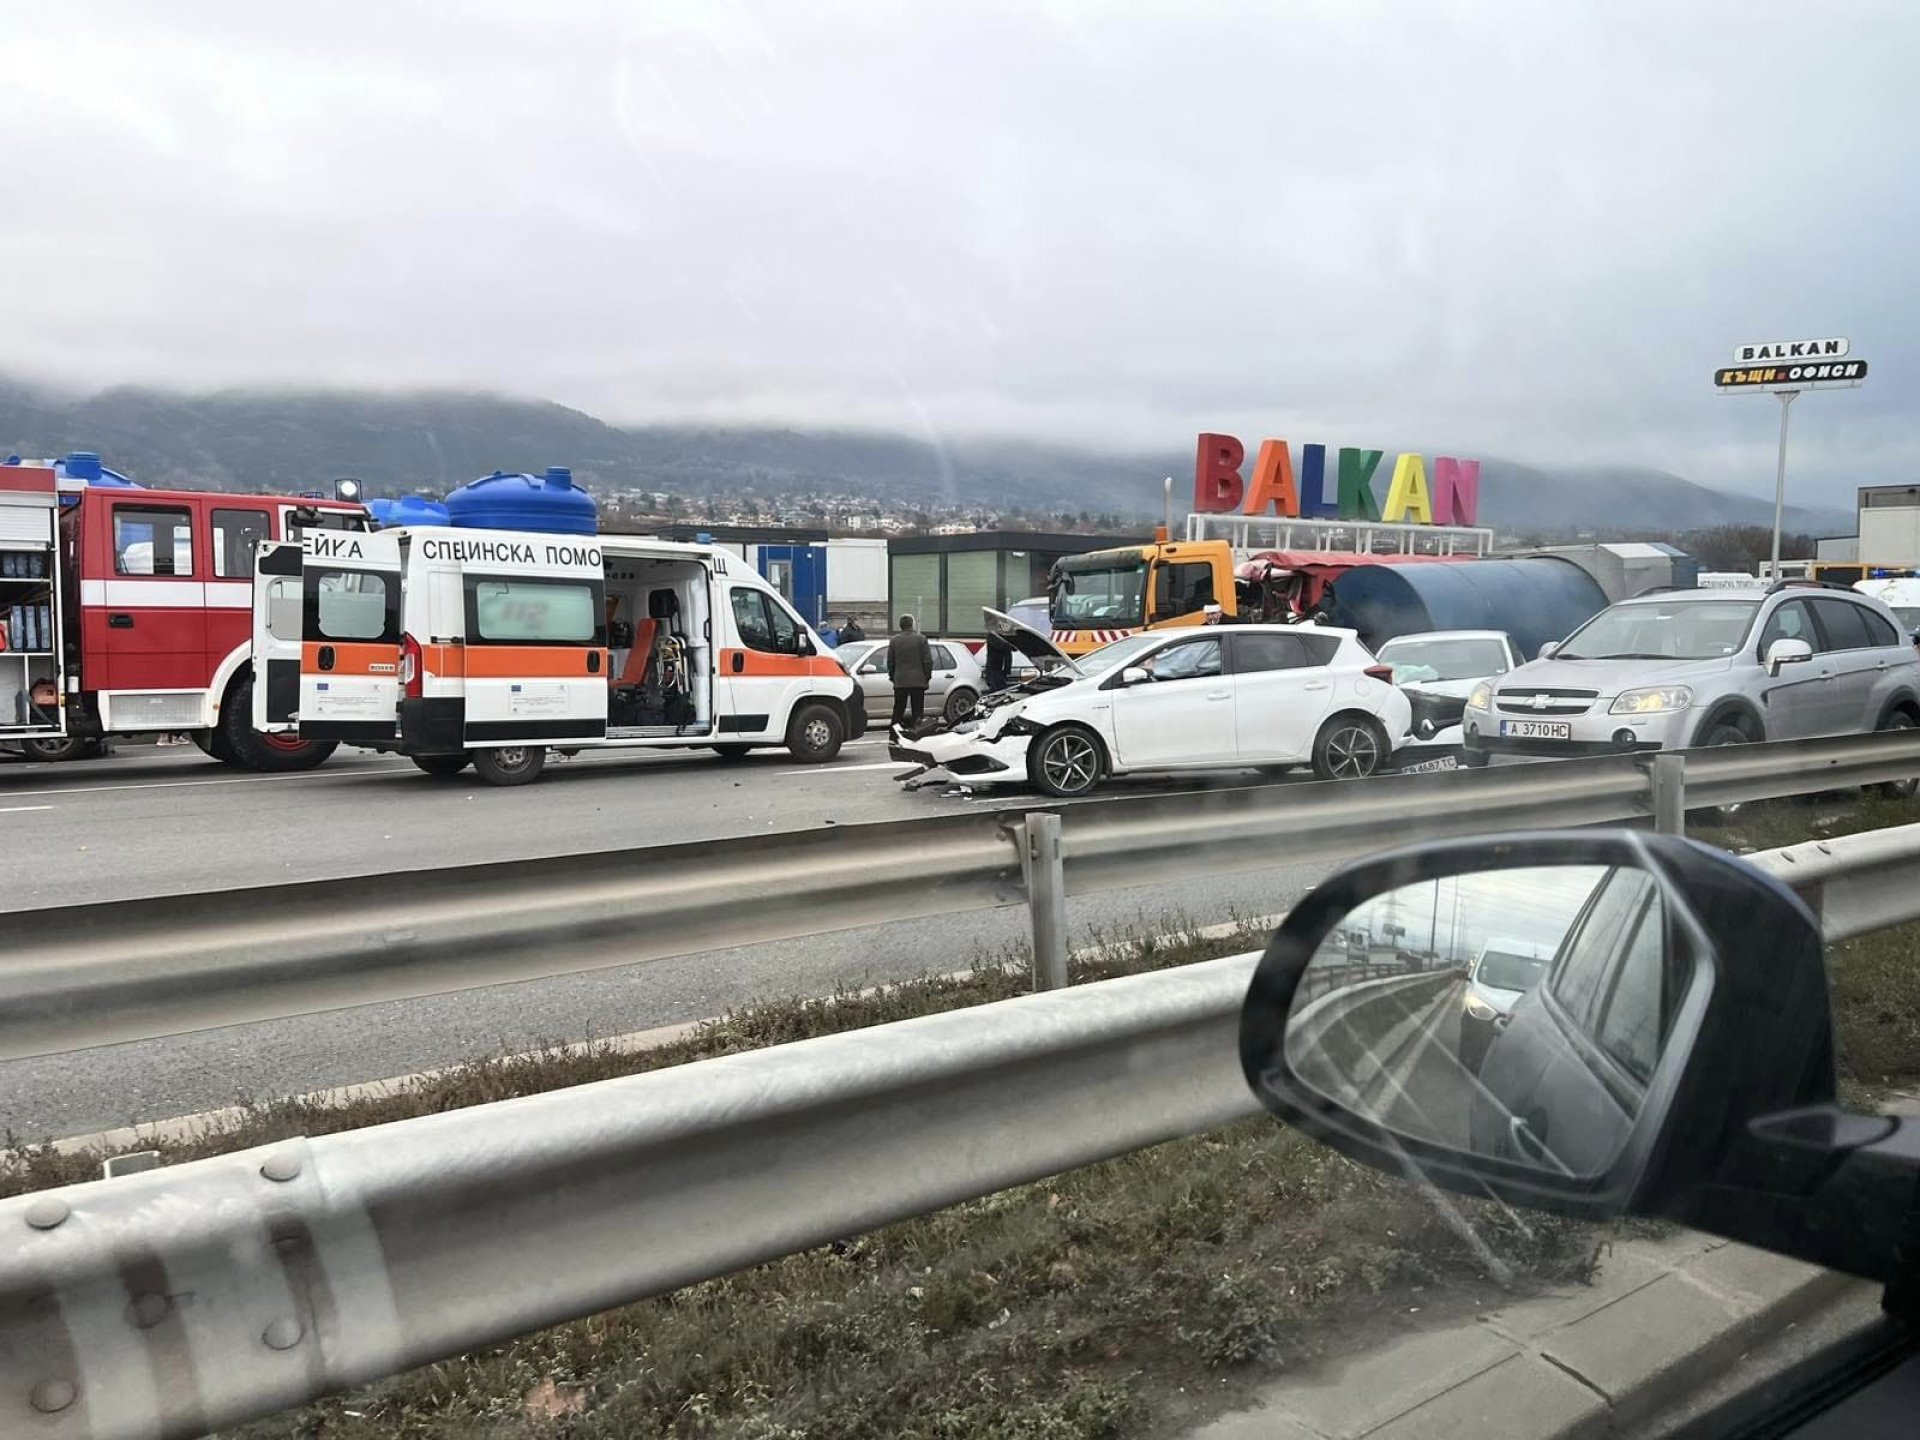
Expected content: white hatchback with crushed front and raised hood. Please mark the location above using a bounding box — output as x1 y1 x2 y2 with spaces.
889 612 1413 797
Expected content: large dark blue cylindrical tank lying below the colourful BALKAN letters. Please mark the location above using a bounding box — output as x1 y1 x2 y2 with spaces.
1329 557 1607 659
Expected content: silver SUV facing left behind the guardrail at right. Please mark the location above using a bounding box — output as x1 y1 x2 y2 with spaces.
1461 580 1920 766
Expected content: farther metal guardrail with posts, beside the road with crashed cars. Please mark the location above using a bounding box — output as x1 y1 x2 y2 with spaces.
11 732 1920 1060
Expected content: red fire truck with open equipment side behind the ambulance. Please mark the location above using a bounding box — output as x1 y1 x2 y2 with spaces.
0 453 369 770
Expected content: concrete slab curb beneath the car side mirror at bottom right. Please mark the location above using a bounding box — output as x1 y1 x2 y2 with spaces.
1188 1233 1876 1440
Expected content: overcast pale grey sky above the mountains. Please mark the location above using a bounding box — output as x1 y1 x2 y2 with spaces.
0 0 1920 503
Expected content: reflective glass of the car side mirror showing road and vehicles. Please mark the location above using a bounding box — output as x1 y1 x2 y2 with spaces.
1284 866 1690 1177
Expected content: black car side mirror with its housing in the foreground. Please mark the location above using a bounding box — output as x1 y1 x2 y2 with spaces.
1240 831 1920 1283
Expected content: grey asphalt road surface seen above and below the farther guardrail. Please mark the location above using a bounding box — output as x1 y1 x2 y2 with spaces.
0 739 1323 1139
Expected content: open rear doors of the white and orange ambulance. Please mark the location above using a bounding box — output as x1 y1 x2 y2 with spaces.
253 530 401 745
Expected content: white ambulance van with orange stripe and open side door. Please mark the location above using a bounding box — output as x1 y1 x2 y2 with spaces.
253 526 866 785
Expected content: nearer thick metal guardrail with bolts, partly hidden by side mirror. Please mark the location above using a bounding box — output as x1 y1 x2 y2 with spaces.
11 826 1920 1440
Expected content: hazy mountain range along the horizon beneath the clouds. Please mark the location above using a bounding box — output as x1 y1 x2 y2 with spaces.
0 378 1853 536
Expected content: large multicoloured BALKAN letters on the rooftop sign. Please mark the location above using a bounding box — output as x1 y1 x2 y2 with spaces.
1194 434 1480 537
